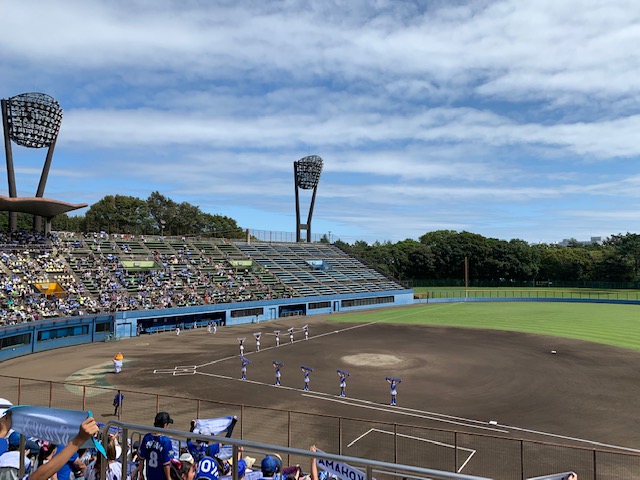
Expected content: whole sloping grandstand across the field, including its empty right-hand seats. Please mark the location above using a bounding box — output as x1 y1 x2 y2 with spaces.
0 234 404 323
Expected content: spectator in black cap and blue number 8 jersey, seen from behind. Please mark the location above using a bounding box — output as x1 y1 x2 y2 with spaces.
134 412 173 480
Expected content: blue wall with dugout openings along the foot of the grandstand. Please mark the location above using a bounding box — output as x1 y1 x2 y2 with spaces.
0 289 414 361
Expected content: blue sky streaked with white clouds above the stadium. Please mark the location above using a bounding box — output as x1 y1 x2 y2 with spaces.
0 0 640 243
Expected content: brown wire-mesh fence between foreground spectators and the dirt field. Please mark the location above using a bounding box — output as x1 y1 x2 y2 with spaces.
0 375 640 480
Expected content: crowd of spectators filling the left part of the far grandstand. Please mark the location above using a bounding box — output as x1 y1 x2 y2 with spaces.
0 232 296 325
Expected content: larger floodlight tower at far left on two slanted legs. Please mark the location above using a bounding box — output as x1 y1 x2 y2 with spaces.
2 93 62 232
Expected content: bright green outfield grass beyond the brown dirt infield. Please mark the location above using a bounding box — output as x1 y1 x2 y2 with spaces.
331 302 640 350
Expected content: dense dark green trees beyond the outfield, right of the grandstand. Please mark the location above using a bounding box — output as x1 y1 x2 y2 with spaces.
336 230 640 288
